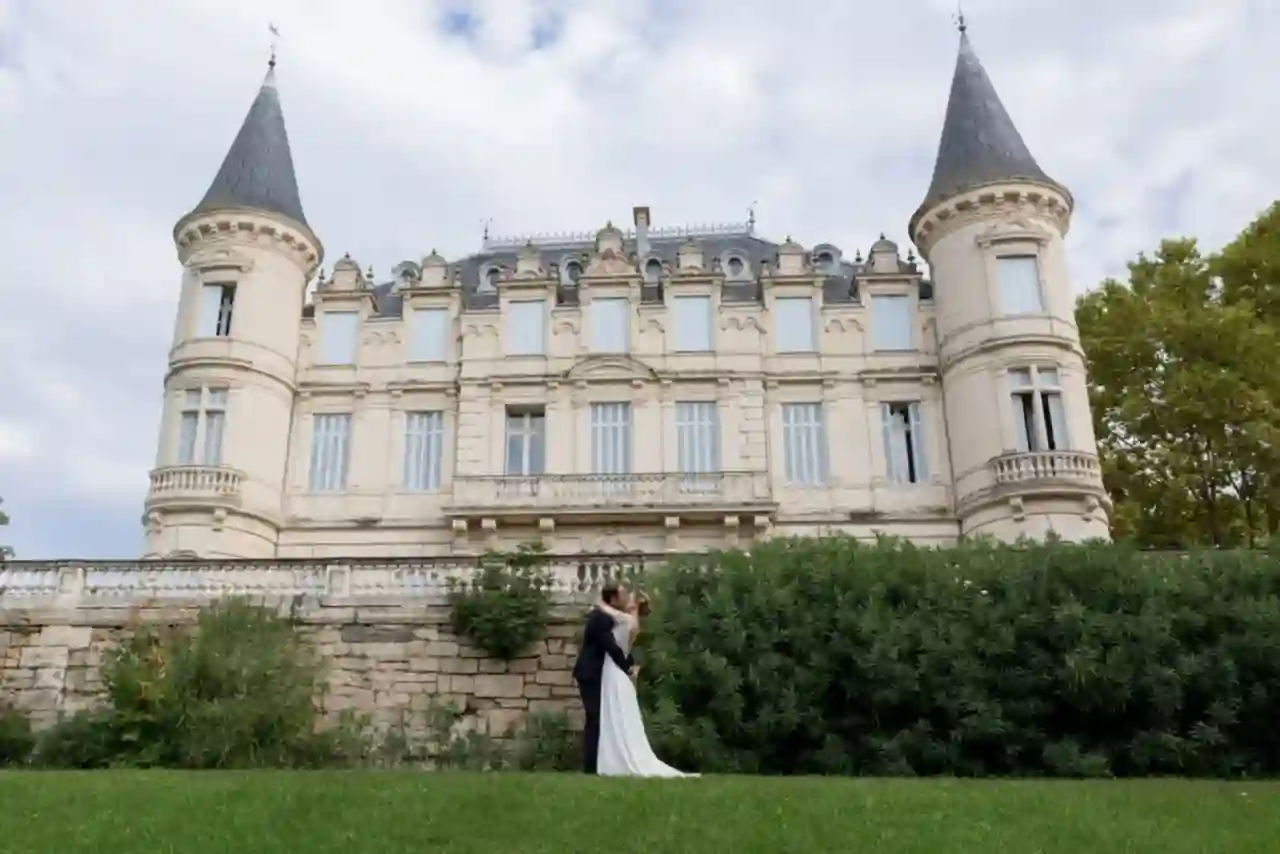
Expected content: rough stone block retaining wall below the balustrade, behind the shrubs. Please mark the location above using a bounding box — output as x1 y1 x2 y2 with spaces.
0 599 584 736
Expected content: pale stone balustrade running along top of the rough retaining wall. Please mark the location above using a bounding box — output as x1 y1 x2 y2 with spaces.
0 553 671 608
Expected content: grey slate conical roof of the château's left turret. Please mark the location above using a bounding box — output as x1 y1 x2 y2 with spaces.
192 59 310 228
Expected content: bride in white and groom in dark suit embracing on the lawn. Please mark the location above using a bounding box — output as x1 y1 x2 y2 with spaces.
573 581 698 777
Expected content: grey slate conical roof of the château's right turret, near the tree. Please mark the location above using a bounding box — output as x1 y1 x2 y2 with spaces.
913 26 1070 220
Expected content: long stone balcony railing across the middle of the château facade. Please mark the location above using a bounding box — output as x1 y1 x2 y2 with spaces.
452 471 772 510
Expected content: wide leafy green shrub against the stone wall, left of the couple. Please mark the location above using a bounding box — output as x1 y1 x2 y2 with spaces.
40 599 358 768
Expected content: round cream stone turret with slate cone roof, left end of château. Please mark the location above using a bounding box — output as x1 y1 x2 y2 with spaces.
143 59 324 557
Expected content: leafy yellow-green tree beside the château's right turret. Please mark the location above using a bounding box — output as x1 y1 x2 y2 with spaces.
1076 226 1280 548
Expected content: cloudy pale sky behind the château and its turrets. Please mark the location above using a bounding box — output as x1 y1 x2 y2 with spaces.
0 0 1280 558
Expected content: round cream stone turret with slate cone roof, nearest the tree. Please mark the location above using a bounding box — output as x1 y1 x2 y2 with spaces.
910 23 1111 540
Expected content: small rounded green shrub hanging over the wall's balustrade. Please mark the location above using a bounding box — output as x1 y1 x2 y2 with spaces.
449 545 552 661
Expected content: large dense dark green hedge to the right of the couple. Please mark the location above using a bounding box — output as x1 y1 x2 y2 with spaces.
641 538 1280 776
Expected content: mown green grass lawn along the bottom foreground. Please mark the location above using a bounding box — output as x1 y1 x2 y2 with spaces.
0 771 1280 854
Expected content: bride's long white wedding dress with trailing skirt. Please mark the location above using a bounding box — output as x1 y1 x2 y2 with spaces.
596 608 698 777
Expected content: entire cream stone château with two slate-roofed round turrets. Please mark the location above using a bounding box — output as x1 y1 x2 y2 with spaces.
143 28 1110 558
